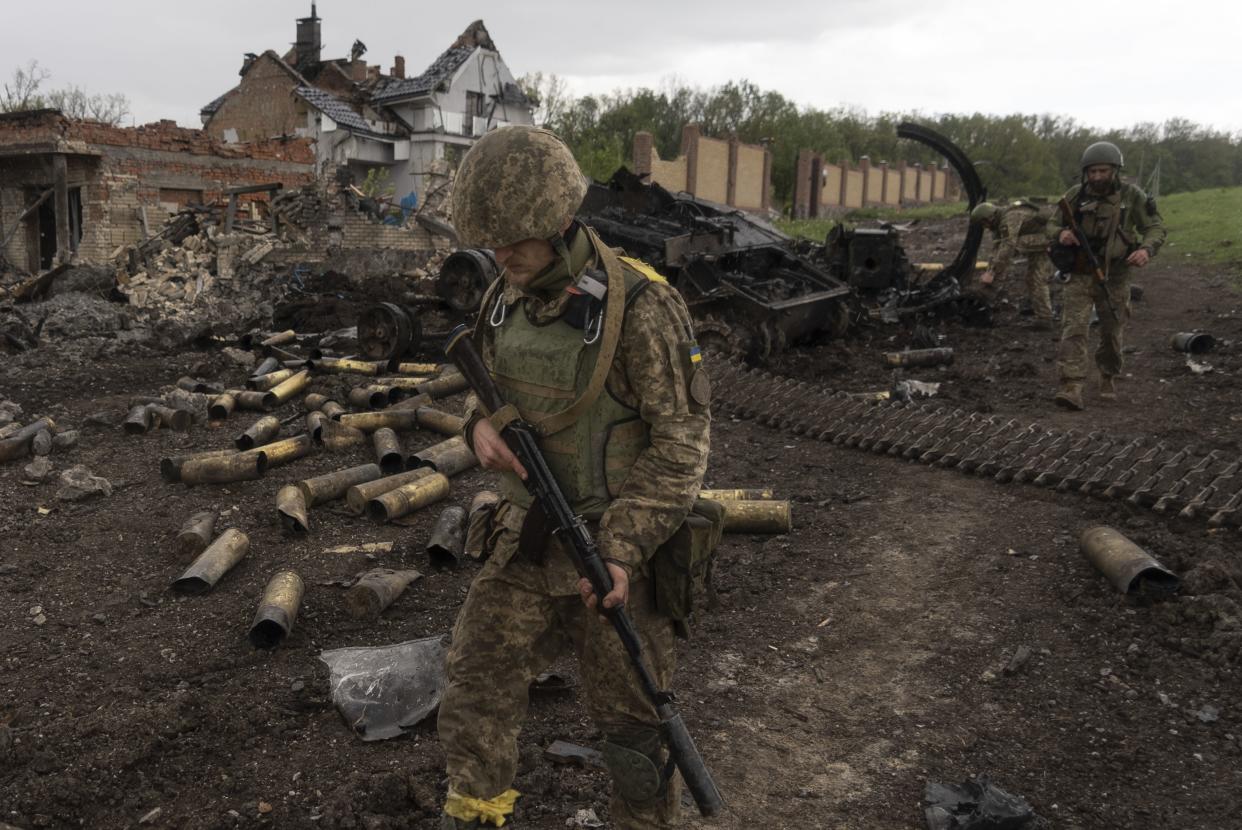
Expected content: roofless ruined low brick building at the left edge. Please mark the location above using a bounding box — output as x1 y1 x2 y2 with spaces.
0 109 315 272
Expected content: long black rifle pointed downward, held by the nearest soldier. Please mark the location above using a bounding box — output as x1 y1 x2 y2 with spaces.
445 326 724 816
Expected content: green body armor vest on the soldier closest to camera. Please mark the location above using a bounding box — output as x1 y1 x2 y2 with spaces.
492 268 651 519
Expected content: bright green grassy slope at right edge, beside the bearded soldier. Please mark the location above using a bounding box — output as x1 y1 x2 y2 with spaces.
1158 188 1242 263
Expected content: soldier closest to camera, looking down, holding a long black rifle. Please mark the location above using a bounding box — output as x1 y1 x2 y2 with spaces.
438 127 710 830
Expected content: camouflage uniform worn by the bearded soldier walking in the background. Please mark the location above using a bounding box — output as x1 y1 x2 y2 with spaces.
1047 184 1166 386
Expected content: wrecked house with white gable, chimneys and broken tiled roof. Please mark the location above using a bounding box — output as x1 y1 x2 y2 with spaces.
201 4 534 207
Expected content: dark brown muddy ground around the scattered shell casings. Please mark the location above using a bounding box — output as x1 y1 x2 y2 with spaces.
0 219 1242 830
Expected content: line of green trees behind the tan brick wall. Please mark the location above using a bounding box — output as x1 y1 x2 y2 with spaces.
520 73 1242 209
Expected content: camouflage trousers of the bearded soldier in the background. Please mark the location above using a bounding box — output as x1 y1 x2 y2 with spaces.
1057 263 1130 383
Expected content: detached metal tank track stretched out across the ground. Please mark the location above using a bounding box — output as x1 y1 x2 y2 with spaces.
712 358 1242 527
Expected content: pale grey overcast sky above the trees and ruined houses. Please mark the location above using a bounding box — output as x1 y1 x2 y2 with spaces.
0 0 1242 132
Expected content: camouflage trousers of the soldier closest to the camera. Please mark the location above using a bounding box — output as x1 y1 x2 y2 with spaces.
438 543 681 830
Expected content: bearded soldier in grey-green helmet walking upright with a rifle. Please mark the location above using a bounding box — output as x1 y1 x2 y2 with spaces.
1048 142 1165 410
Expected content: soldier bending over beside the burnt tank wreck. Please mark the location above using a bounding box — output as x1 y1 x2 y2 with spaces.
970 199 1052 329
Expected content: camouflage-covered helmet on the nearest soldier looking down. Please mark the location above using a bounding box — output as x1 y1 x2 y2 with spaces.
453 125 586 249
